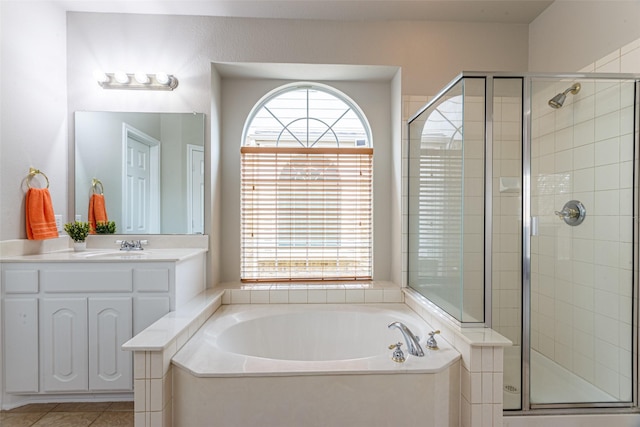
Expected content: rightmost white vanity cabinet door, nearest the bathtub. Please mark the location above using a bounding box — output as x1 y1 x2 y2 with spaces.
89 297 132 391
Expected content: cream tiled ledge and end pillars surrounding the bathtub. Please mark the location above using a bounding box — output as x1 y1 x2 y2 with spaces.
126 282 510 427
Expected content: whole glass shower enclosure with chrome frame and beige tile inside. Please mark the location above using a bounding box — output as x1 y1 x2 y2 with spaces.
407 73 640 411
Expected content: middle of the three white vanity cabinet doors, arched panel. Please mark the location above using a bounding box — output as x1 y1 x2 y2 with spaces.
42 298 89 391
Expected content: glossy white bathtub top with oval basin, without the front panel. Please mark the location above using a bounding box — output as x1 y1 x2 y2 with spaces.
173 304 459 377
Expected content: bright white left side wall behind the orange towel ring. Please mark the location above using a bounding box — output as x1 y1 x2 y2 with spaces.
0 1 68 244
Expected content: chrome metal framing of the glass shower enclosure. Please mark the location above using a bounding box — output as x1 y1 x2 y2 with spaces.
408 72 640 416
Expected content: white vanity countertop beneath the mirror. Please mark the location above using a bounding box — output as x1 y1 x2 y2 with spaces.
0 248 207 262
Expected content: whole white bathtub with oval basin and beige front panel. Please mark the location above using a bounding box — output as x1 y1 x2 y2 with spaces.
172 304 460 427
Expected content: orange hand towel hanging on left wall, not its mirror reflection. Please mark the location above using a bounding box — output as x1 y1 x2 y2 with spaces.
25 188 58 240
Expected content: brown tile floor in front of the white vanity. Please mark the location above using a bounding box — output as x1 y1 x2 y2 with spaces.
0 402 133 427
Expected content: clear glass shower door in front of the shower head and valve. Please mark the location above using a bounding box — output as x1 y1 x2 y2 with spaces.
524 78 638 409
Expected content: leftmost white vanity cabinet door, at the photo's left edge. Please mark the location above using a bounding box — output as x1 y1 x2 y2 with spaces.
3 298 40 393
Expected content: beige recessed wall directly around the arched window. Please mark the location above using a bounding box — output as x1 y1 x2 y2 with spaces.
220 76 400 282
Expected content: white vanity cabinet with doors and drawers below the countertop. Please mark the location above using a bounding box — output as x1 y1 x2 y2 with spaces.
0 254 205 394
